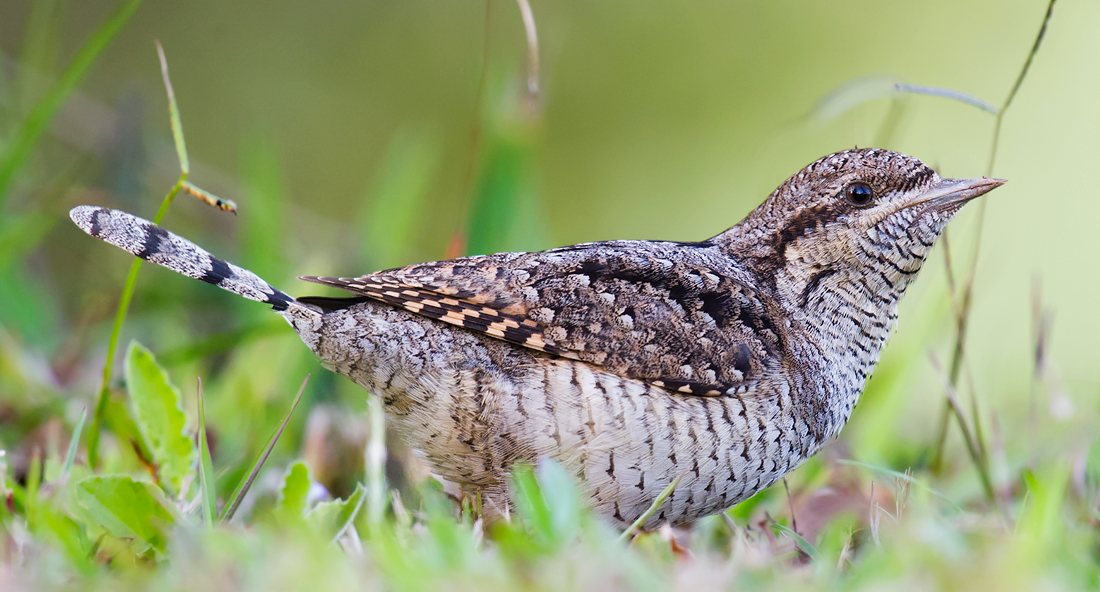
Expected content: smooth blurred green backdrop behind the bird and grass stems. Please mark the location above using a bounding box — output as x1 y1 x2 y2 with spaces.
0 0 1100 530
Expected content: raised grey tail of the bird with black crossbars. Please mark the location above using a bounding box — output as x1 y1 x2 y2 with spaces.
69 206 296 313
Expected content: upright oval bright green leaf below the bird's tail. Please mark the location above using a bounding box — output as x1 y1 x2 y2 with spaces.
127 341 195 491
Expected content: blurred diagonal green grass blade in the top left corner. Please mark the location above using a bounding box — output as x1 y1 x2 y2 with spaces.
0 0 142 204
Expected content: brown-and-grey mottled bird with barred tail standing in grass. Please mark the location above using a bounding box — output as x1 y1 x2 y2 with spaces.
70 149 1004 529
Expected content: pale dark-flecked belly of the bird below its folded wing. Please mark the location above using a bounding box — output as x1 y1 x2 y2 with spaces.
296 303 807 526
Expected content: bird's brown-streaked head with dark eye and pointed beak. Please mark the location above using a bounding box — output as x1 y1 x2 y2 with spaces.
716 149 1004 307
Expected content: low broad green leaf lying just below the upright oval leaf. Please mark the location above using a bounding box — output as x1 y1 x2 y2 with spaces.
76 475 180 555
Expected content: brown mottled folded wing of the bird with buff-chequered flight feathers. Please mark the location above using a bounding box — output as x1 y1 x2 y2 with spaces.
303 241 779 395
